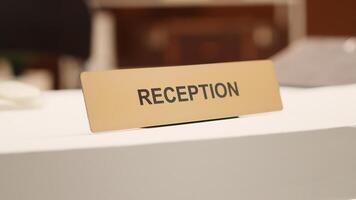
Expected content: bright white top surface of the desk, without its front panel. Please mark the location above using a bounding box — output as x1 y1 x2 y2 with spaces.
0 84 356 154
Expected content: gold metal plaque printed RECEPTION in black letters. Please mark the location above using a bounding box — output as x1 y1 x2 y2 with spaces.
81 60 282 132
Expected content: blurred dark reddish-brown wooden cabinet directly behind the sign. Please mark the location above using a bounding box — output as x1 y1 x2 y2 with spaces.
109 5 288 67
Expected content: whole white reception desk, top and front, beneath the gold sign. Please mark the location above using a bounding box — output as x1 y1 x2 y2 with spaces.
0 85 356 200
